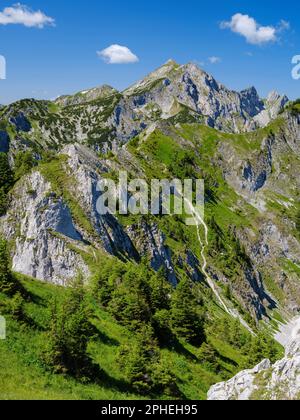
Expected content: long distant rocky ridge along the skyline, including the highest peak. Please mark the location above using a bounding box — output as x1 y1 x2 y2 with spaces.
1 61 288 151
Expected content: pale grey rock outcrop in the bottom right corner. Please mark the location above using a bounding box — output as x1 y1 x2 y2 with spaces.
208 321 300 401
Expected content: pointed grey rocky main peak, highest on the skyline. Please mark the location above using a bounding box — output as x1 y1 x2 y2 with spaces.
111 62 251 141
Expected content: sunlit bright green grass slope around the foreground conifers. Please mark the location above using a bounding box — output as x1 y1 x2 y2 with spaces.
0 276 258 400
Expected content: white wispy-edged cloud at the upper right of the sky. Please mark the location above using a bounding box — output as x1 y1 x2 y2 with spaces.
221 13 282 45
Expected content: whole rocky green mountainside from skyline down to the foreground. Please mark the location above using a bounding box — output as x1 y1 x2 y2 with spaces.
0 60 300 399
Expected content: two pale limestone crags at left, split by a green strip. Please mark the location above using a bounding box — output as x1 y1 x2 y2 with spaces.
0 145 139 284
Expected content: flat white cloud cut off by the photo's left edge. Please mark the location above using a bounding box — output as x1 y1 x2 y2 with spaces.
0 3 55 28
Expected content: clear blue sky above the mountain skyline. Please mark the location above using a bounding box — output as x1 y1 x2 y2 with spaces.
0 0 300 103
